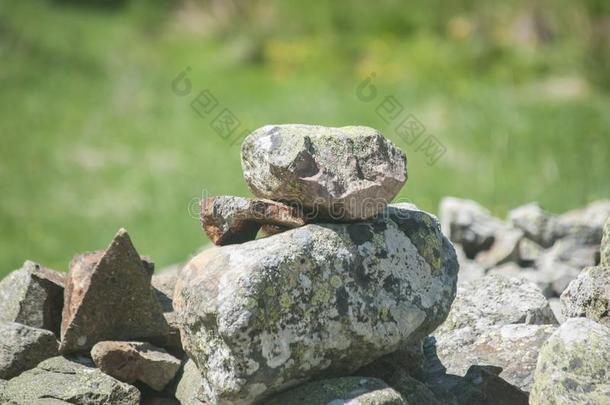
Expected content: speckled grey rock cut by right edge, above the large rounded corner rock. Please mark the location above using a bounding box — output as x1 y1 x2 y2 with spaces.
561 267 610 327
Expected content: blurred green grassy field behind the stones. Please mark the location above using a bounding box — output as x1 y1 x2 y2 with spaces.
0 0 610 277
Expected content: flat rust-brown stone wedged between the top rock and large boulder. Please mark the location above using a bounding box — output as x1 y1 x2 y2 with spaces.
201 196 305 246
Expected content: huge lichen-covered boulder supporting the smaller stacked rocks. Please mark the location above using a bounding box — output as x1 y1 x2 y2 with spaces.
174 206 458 404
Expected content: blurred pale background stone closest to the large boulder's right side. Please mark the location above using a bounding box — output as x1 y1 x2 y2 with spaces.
439 197 507 259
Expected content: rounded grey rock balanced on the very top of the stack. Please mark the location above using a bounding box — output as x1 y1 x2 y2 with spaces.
241 125 407 222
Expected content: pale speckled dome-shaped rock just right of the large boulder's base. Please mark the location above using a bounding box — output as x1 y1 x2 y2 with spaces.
435 275 557 335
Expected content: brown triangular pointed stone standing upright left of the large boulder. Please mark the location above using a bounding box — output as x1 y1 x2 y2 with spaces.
60 229 168 353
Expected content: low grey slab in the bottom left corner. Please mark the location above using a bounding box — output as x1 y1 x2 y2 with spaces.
2 357 140 405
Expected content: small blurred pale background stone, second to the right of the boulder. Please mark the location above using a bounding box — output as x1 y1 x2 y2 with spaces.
508 202 556 248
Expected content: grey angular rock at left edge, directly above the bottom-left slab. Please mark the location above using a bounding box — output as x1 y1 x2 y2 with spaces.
0 322 58 380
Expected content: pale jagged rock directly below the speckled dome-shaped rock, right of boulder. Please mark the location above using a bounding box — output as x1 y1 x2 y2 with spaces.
426 324 557 391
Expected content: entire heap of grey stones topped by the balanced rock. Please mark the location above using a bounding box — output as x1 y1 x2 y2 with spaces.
0 125 610 405
